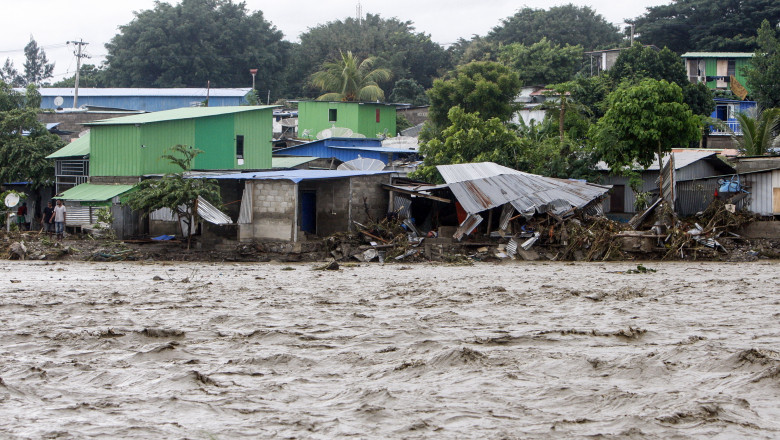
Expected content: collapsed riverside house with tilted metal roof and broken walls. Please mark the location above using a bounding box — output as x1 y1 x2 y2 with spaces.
385 162 610 240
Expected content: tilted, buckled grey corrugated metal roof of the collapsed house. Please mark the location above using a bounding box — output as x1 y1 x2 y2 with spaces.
436 162 610 214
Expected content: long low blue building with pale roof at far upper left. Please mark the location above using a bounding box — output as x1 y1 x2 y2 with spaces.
27 87 251 112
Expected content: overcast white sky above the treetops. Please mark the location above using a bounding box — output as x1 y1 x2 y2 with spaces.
0 0 671 81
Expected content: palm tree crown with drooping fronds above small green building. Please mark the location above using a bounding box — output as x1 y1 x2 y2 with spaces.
311 51 392 102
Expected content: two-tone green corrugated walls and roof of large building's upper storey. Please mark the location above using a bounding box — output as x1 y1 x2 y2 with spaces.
85 106 275 176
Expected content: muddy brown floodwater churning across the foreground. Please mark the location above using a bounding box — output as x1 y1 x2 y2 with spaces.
0 261 780 439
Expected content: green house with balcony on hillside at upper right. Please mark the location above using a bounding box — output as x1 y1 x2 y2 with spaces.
682 52 753 92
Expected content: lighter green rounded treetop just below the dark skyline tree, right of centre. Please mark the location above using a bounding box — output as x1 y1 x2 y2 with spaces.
499 37 583 86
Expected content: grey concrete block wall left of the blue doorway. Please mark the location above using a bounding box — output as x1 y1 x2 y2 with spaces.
239 180 298 241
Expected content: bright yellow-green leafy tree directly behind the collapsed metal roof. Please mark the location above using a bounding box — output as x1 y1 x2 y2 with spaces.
412 108 521 182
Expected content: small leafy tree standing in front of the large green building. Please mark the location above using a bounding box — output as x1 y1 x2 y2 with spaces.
127 145 222 248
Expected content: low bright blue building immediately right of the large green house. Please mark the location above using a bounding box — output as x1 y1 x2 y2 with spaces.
274 138 418 164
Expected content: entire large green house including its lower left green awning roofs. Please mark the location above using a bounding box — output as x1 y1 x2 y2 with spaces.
48 106 275 236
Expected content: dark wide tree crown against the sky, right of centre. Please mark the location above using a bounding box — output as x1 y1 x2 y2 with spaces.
487 3 621 50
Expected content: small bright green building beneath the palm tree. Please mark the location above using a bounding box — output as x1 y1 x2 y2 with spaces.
298 101 396 139
